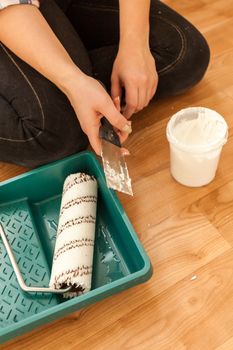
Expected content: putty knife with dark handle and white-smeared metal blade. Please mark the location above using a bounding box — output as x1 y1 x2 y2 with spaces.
100 117 133 196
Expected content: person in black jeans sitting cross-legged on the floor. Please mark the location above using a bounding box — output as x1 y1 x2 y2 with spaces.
0 0 209 167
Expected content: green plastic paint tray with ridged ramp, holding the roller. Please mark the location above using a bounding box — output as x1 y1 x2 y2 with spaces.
0 152 152 343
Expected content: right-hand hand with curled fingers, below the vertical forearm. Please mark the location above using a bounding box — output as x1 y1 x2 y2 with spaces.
111 45 158 118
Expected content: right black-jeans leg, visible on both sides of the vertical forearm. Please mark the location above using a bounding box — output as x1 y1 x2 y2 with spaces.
67 0 209 97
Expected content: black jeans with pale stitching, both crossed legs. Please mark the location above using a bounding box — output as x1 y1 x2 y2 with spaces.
0 0 209 168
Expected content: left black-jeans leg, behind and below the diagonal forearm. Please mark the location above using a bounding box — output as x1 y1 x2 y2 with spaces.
0 1 92 167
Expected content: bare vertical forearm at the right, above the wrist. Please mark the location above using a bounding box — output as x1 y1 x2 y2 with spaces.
119 0 150 46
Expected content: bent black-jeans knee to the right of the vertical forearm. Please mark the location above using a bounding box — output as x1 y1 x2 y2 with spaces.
151 0 210 97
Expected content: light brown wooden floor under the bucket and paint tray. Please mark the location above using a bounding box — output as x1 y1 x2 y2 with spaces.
0 0 233 350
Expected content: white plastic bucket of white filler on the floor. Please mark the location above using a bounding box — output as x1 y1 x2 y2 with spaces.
166 107 228 187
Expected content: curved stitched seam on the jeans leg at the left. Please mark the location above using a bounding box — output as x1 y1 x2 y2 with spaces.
0 42 45 142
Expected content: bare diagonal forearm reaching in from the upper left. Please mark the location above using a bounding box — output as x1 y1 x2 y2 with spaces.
0 5 82 91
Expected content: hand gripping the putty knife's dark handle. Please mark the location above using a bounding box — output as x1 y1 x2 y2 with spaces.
63 71 131 155
